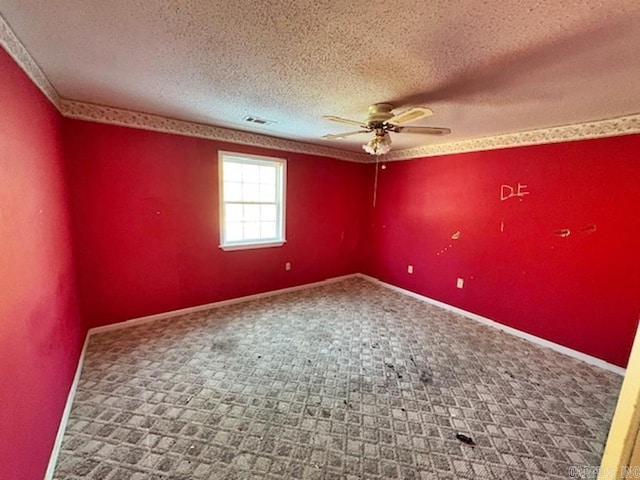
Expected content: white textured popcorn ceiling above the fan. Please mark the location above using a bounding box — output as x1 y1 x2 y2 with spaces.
0 0 640 156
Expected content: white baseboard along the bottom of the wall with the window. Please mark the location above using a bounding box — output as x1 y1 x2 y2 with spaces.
89 273 360 335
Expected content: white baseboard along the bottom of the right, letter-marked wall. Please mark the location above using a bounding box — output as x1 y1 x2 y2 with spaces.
357 273 626 376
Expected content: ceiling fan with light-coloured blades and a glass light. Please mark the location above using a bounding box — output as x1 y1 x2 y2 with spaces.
322 103 451 155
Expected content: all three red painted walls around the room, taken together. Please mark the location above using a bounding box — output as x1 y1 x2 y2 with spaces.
0 30 640 480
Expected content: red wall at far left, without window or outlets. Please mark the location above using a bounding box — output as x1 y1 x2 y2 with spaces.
0 49 86 480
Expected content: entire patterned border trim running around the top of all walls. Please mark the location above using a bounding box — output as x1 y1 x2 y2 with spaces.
0 15 640 163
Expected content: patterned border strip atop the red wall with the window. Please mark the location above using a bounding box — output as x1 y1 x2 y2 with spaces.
60 99 369 163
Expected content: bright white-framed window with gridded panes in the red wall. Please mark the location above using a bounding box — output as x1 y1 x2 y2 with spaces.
219 152 286 250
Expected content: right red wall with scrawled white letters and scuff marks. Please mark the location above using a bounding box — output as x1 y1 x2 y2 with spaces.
365 135 640 366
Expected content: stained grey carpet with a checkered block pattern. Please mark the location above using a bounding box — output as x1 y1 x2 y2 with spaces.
54 279 622 480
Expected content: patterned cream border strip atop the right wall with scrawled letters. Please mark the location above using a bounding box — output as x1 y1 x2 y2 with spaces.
383 114 640 162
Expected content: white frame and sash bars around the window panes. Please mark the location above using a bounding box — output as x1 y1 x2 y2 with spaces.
218 151 287 250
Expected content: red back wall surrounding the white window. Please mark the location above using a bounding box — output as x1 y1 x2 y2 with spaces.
65 120 366 326
